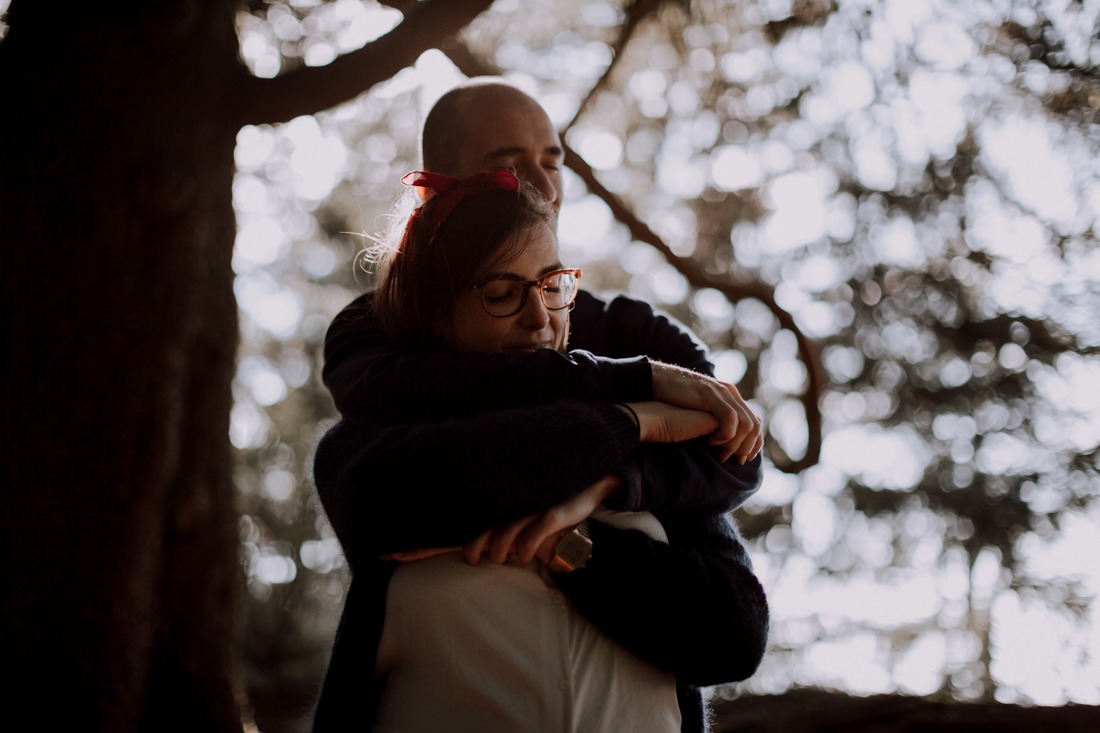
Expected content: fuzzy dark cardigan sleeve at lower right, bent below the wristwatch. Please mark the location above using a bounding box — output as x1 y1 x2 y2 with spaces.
554 512 769 686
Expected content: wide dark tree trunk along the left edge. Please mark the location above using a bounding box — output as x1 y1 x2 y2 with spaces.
0 0 241 731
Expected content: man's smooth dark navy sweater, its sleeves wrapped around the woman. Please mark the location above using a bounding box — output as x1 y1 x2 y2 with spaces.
323 291 760 514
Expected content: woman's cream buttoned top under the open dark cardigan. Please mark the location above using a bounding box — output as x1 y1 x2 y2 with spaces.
373 511 680 733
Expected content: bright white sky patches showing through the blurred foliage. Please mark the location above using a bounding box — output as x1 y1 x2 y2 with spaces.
223 0 1100 704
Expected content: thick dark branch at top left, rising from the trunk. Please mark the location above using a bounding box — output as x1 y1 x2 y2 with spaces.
231 0 493 125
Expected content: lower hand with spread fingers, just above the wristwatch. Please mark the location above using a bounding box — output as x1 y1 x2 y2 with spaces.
462 473 623 565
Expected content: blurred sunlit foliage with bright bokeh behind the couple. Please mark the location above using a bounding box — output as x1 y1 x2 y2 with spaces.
232 0 1100 721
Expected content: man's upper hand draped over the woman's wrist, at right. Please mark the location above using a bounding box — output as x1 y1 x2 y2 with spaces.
651 361 763 464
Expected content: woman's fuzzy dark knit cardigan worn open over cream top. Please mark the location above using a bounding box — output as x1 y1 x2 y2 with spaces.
315 402 768 731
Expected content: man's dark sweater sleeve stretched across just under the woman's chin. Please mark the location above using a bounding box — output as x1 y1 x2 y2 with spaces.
322 294 652 417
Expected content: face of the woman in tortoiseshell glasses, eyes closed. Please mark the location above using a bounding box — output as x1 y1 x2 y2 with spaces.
438 226 569 353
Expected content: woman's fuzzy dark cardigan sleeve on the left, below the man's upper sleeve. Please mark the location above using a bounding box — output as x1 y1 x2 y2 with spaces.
314 401 638 569
